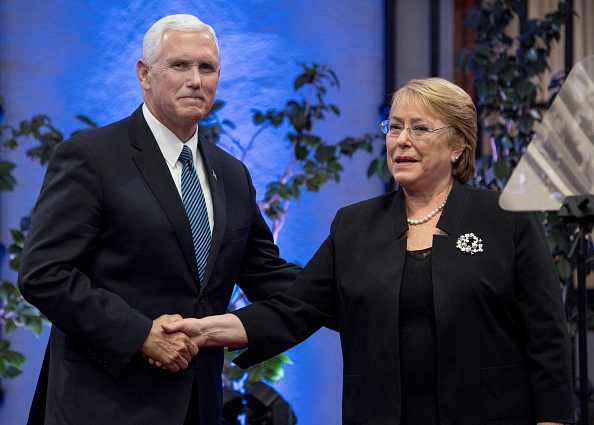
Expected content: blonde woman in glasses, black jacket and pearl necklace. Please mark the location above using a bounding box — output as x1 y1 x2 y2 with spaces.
164 78 573 425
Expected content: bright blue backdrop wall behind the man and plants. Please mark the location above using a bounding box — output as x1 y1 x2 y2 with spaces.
0 0 386 425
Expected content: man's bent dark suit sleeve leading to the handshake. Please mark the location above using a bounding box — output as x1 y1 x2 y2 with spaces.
18 141 152 375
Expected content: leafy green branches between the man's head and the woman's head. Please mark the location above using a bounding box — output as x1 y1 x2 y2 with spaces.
200 63 389 240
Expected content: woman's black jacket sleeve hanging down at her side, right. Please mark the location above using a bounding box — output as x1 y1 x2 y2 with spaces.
515 213 573 423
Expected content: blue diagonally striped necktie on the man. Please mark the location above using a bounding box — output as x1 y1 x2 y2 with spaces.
179 146 210 284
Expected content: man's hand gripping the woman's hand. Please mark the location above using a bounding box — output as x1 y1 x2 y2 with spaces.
140 314 198 372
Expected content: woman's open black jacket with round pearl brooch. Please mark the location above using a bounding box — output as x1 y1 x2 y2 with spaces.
235 183 573 425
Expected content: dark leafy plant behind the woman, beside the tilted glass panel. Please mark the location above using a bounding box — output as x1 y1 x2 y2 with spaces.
457 0 594 335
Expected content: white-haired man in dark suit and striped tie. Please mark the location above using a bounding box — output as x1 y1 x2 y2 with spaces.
19 15 299 425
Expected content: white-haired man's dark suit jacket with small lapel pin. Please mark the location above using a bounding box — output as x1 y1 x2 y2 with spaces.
19 108 299 425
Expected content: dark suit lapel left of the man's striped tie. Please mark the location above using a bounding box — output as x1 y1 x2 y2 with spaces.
128 108 200 285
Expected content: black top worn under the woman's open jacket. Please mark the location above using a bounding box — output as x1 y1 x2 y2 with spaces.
398 248 438 425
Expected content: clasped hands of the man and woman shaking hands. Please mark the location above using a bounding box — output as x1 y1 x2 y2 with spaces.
140 314 248 372
